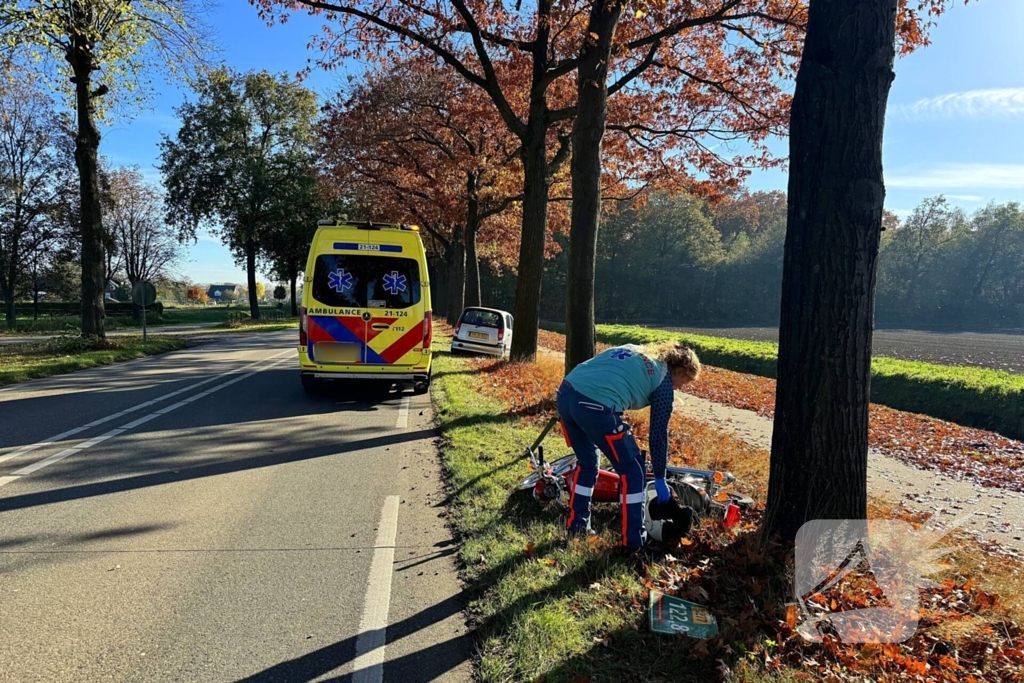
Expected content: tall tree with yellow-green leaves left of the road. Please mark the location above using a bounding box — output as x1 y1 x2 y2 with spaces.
0 0 207 337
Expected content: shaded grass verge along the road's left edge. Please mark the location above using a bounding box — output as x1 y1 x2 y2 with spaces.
0 337 185 386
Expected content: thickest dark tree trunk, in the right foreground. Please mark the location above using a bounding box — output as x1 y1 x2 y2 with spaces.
765 0 897 539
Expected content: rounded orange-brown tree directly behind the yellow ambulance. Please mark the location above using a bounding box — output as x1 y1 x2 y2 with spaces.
321 58 522 323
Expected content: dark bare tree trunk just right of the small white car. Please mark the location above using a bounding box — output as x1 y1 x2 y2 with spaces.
510 129 548 360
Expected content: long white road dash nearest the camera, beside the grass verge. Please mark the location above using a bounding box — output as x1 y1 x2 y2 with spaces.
352 496 398 683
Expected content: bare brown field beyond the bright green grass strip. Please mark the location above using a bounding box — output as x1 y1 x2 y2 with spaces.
662 327 1024 374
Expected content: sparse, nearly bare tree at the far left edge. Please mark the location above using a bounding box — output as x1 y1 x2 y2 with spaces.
0 68 74 325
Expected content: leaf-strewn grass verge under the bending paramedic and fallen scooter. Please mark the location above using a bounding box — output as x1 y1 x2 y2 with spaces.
433 340 1024 683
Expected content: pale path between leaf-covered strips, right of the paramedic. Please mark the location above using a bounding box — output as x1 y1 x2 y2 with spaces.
676 392 1024 556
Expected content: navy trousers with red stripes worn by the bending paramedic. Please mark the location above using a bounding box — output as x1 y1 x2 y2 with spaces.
558 382 647 548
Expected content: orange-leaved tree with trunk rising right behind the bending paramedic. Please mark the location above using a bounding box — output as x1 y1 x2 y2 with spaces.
565 0 948 371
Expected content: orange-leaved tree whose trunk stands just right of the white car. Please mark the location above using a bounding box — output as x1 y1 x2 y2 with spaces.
255 0 578 359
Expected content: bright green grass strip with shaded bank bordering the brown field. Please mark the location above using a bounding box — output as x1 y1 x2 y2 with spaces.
545 324 1024 439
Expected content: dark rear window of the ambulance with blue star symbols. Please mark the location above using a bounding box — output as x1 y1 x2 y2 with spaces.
312 254 420 308
